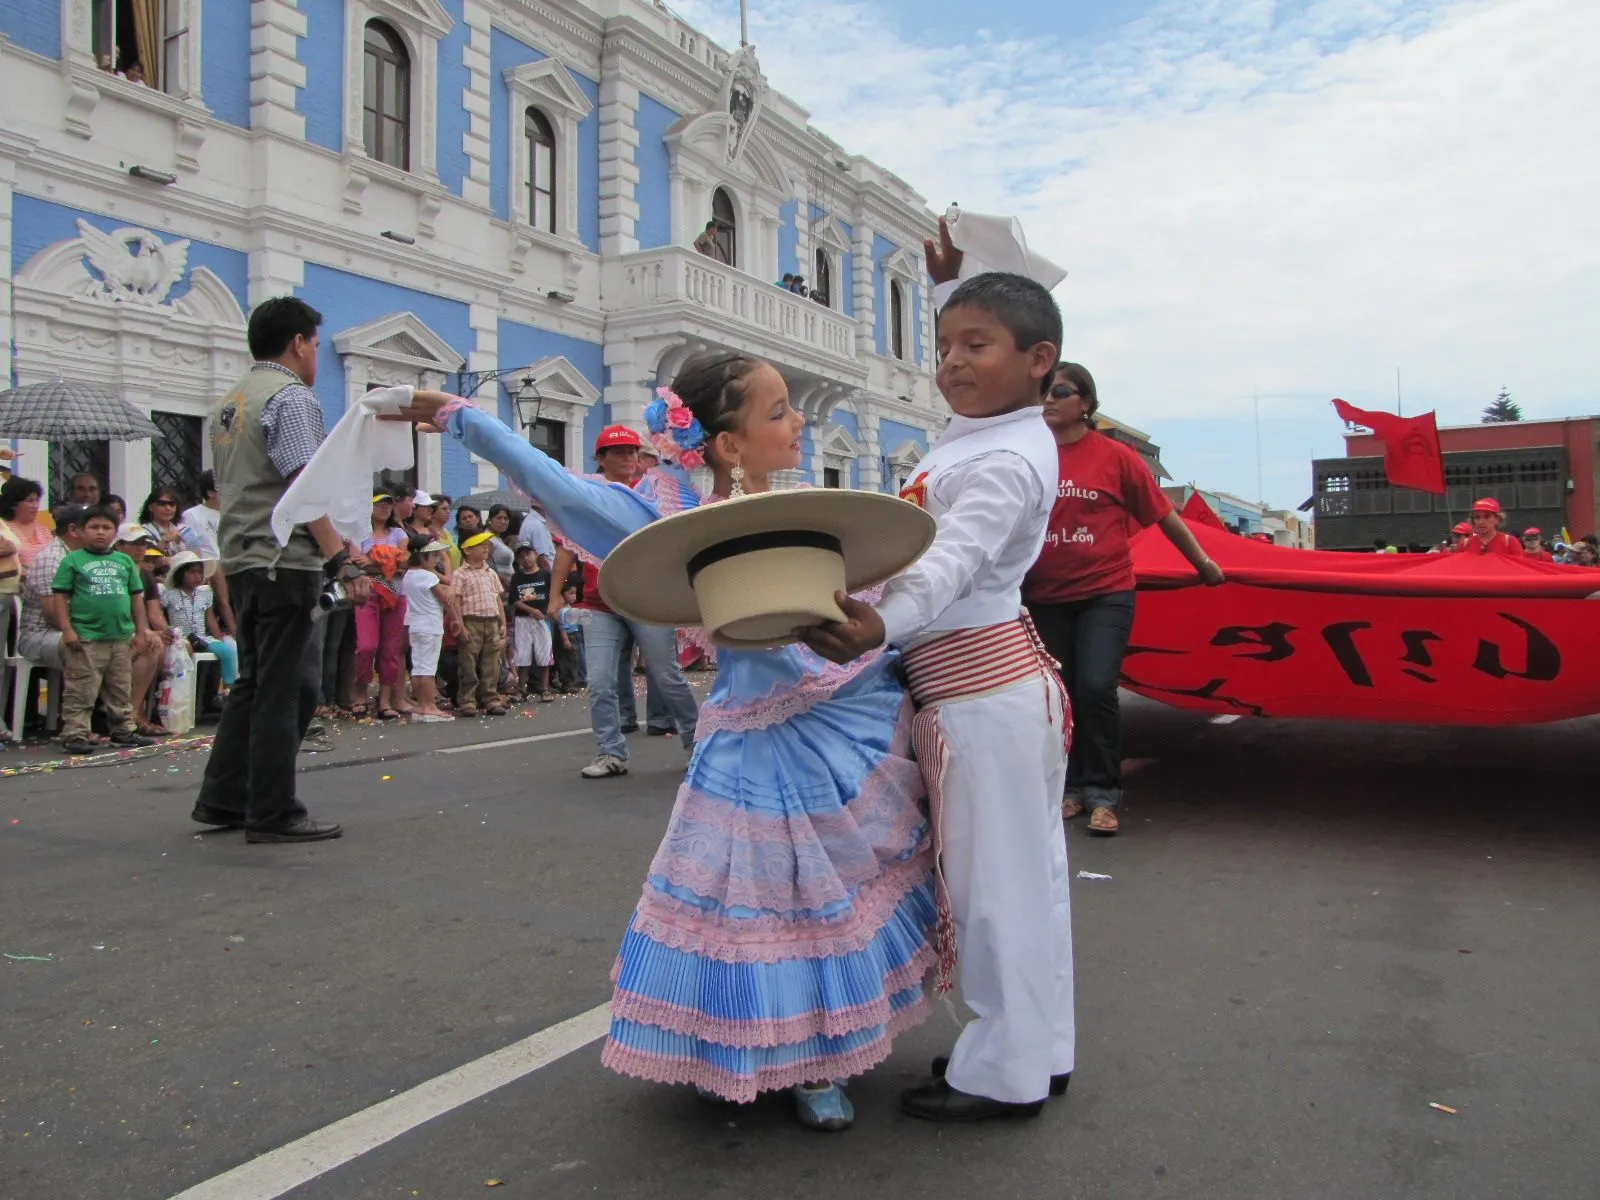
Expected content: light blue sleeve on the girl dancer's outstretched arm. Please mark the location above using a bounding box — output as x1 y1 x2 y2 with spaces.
445 406 661 558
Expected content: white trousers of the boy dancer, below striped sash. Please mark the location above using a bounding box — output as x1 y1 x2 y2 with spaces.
938 678 1075 1104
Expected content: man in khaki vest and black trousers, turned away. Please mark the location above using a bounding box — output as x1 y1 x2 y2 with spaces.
192 296 368 842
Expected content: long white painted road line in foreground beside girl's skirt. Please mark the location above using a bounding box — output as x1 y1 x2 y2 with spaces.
173 1004 611 1200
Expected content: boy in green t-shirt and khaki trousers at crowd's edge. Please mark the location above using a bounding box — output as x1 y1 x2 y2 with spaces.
50 509 155 754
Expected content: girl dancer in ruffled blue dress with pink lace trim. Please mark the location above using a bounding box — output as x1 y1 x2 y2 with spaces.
396 354 936 1130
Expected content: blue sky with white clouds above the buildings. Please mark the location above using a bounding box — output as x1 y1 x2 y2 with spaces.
672 0 1600 507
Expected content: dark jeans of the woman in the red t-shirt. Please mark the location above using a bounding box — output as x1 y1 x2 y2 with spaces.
1029 592 1133 808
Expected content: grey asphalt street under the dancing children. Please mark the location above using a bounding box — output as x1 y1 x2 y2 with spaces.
0 701 1600 1200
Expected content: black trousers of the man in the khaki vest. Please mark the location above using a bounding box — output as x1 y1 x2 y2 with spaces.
198 568 323 829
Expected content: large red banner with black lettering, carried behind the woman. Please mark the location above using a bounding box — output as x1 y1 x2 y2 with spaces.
1123 522 1600 725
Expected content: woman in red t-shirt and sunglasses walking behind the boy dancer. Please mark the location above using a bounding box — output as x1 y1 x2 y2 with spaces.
1022 363 1222 835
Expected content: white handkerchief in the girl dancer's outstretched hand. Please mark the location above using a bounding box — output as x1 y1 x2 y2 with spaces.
272 386 416 546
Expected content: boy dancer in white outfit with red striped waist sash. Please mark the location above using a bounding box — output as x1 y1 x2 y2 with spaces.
803 272 1074 1122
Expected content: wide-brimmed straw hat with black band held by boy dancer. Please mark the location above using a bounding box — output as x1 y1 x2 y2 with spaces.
600 488 936 650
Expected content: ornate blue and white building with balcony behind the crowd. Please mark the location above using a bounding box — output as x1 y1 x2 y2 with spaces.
0 0 946 504
